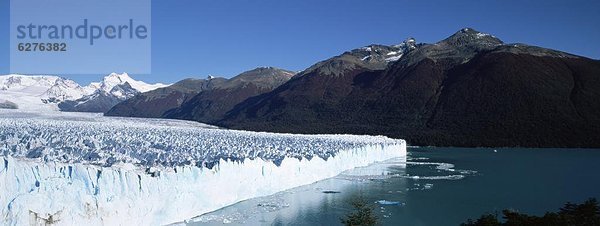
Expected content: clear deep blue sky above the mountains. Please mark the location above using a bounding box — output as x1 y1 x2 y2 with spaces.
0 0 600 83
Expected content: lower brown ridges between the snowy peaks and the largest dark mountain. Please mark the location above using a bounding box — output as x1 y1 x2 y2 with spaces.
105 67 294 123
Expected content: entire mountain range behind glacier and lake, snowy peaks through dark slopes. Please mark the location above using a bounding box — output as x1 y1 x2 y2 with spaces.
0 28 600 147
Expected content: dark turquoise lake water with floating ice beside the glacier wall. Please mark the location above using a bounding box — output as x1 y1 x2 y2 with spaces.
188 148 600 225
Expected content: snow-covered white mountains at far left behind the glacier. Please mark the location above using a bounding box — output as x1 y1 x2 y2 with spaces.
0 73 165 112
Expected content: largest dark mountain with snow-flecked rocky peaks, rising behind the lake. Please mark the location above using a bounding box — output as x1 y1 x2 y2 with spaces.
219 28 600 147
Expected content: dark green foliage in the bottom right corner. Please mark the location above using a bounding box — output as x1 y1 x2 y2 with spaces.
461 199 600 226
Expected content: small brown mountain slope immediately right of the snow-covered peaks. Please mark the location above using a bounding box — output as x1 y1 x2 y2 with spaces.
105 76 226 118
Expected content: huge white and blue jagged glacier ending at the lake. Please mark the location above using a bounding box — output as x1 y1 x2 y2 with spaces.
0 110 406 225
